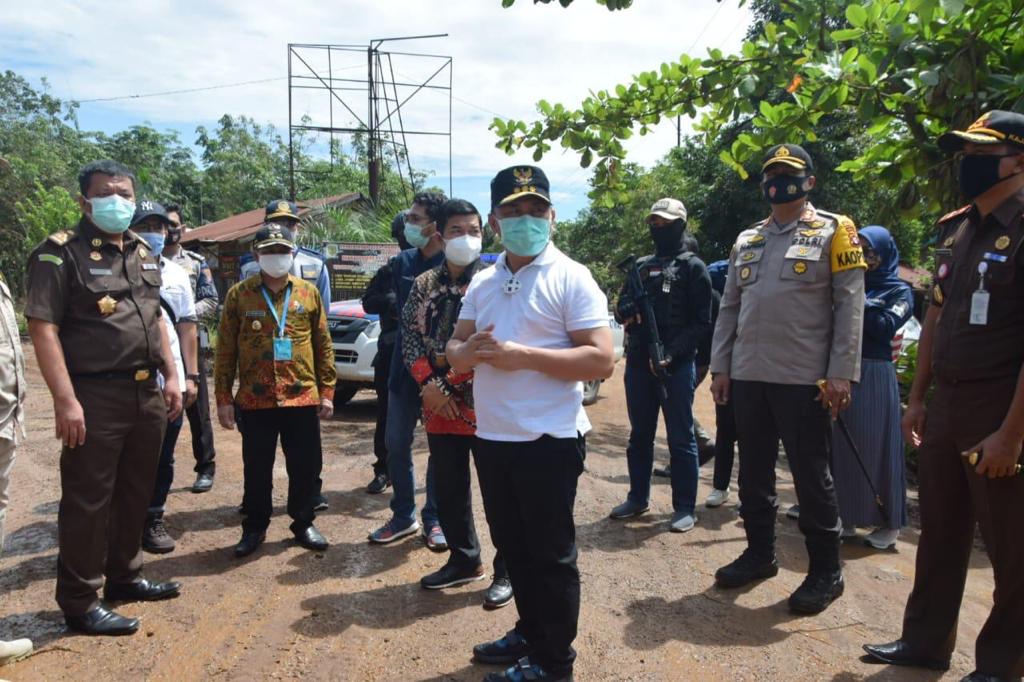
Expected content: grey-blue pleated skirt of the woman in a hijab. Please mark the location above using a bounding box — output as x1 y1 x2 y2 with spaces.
831 358 906 528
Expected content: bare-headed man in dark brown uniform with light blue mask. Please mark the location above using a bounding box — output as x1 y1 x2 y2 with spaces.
25 161 181 635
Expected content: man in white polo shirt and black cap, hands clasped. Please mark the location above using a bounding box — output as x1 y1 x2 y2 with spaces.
447 166 614 682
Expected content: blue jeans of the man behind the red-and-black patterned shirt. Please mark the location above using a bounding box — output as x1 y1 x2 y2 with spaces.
384 382 437 528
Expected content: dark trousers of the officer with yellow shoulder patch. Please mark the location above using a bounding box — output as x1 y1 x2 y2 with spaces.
731 380 842 572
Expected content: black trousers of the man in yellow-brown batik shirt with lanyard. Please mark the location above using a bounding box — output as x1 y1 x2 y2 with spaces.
238 407 323 532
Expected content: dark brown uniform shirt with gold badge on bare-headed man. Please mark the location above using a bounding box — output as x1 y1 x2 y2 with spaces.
25 218 163 377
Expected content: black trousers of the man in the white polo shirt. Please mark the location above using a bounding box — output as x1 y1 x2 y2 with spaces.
475 435 586 675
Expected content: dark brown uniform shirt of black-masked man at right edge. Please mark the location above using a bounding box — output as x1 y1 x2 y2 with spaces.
932 191 1024 382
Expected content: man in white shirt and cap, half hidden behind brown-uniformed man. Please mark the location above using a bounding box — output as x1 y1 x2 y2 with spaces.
131 199 200 554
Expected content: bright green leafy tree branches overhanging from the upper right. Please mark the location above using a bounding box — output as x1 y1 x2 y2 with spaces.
492 0 1024 212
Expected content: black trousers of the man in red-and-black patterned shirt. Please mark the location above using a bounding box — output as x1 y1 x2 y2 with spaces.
427 433 508 578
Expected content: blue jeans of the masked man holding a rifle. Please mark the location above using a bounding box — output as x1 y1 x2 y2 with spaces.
626 357 697 514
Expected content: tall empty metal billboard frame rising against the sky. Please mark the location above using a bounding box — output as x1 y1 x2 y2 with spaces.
288 34 453 204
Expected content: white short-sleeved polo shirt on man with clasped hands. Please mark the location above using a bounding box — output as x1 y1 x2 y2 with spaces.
459 244 608 441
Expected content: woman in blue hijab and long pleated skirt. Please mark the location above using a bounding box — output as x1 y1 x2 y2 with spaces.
833 225 913 549
